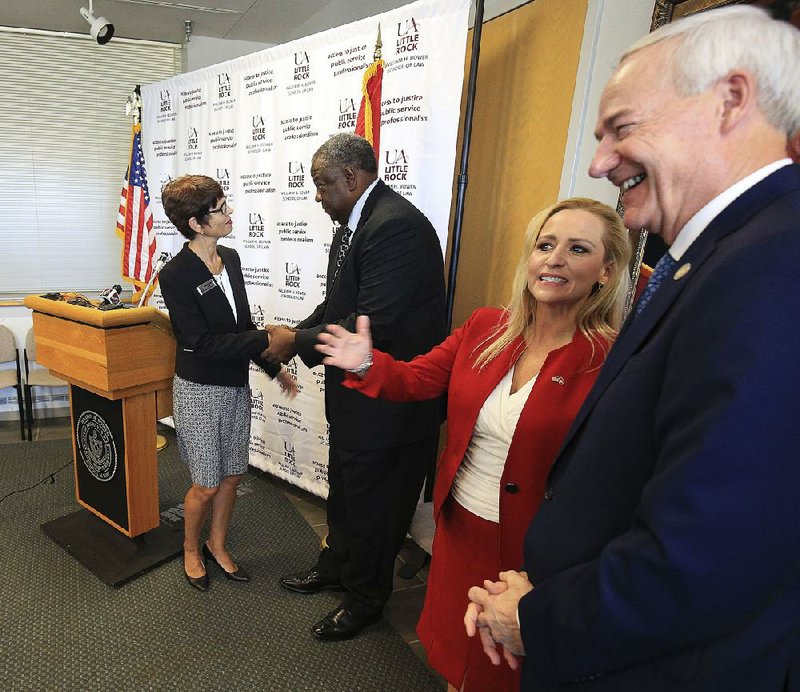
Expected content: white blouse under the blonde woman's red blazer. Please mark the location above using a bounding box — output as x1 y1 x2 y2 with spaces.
451 368 536 522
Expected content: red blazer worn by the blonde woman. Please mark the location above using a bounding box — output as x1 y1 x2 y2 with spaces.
344 308 608 569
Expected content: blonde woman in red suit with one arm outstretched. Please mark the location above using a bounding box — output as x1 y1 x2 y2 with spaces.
317 198 630 692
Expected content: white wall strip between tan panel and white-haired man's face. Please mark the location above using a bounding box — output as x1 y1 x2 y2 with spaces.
559 0 653 207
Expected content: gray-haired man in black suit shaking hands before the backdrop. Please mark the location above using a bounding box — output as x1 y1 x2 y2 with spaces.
270 134 445 640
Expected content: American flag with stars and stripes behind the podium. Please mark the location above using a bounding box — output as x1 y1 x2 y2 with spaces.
117 123 156 284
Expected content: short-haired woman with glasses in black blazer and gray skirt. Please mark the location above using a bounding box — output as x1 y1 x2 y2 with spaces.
159 175 297 591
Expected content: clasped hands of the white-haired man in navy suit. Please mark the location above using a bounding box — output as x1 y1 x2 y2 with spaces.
464 570 533 670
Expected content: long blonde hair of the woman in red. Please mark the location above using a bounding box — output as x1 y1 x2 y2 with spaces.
475 197 631 368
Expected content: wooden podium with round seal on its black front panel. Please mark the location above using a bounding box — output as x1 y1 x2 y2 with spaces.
25 296 182 585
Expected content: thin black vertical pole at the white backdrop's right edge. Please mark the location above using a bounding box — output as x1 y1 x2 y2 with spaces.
445 0 484 334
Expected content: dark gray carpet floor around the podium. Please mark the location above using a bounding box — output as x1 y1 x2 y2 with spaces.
0 441 441 692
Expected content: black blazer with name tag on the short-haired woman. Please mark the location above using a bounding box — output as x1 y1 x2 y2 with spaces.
159 243 280 387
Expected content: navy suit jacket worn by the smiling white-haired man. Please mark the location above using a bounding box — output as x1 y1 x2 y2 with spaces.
519 165 800 692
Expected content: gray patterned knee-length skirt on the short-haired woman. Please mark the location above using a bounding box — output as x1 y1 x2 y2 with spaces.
172 375 250 488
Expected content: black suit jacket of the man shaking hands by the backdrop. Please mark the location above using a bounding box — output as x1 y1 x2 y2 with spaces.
295 180 445 451
